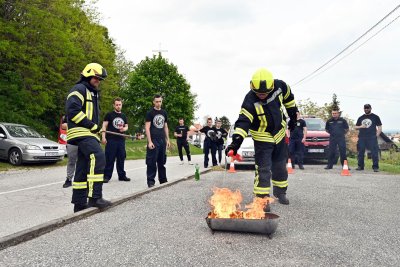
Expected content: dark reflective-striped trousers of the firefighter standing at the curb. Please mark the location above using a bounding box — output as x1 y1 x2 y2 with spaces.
71 137 106 205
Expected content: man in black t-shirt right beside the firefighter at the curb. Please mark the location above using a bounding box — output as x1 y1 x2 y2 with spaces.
102 97 131 183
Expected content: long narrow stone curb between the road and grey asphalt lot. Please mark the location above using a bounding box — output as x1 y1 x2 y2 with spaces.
0 169 213 250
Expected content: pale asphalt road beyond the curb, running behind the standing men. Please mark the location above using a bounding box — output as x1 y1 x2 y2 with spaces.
0 155 203 238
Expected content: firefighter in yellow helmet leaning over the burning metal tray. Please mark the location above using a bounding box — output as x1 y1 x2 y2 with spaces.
225 68 298 208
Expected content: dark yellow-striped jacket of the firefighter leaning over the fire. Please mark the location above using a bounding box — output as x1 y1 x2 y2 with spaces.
233 79 297 143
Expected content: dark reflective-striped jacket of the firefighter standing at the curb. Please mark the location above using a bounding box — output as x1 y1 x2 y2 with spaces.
66 81 100 141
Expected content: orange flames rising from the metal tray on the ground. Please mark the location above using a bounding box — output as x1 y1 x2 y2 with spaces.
208 187 274 219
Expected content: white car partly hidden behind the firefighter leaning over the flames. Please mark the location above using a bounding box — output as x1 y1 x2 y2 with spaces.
225 126 255 168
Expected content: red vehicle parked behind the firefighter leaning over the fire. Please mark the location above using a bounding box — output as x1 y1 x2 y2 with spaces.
303 116 329 160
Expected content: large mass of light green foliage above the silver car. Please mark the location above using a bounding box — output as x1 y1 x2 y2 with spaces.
0 0 129 138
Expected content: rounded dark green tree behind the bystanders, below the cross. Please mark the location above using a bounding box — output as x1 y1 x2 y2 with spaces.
121 53 197 135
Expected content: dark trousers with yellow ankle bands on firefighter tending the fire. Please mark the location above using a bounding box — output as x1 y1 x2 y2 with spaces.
253 139 288 197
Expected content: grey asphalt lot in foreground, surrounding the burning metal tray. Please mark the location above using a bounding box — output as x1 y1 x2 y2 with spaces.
0 165 400 266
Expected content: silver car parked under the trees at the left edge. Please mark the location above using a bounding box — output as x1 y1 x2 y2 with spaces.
0 123 66 165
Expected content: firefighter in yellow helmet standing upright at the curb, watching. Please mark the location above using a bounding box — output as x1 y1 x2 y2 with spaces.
66 63 111 212
